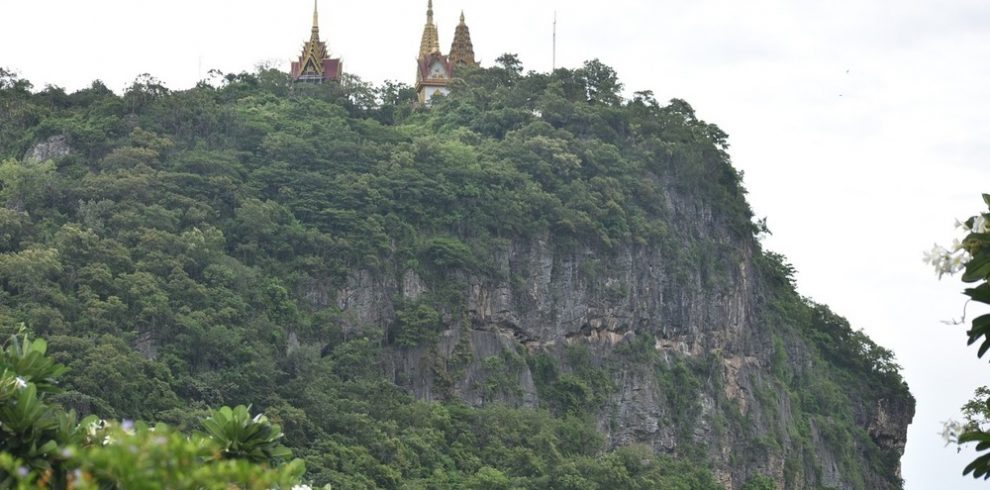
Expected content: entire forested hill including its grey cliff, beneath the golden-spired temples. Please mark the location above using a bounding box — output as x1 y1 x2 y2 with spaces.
0 55 914 490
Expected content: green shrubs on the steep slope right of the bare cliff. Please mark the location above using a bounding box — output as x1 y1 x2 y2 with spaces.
760 223 914 488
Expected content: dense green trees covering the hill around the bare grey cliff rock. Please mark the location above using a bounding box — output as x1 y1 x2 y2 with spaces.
0 55 906 490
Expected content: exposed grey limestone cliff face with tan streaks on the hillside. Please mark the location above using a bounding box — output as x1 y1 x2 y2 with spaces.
308 189 914 488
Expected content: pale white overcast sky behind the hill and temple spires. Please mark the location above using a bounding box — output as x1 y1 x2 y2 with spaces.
0 0 990 490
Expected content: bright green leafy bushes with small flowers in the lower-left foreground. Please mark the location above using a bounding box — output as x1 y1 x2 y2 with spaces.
0 334 305 489
